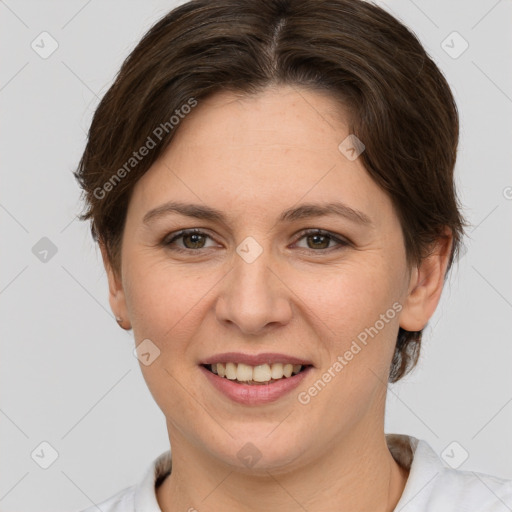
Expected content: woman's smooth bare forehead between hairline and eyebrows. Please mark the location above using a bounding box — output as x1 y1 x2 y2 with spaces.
126 87 390 228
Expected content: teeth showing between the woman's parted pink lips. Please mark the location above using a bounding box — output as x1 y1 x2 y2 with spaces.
202 362 310 385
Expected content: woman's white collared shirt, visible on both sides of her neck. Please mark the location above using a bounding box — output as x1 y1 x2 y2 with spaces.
81 434 512 512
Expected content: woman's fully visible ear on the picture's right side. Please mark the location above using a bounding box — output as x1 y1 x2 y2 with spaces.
400 228 453 331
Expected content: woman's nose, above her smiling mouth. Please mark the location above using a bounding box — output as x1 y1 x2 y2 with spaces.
216 250 292 335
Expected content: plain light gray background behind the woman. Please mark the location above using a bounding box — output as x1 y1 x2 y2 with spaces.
0 0 512 512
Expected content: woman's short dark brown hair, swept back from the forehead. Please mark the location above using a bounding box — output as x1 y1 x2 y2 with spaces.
75 0 465 382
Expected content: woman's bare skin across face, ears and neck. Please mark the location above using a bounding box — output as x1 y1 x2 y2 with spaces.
102 86 451 512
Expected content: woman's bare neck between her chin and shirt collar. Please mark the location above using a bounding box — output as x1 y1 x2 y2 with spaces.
157 424 408 512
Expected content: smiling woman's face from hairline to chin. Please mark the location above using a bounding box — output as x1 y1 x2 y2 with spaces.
111 87 424 469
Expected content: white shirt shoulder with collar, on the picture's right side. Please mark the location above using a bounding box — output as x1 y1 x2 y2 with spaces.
395 436 512 512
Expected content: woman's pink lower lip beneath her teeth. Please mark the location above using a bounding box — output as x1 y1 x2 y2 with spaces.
199 366 312 405
